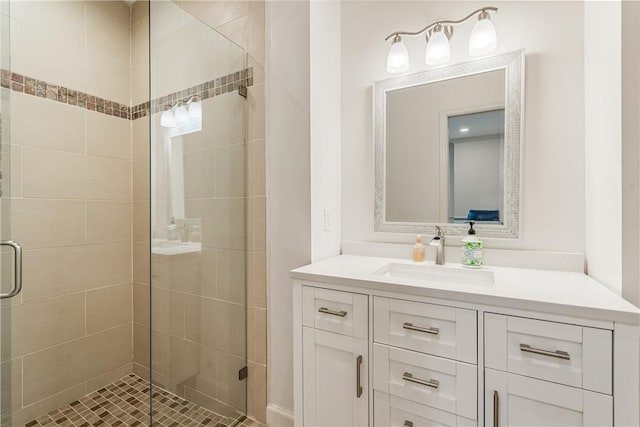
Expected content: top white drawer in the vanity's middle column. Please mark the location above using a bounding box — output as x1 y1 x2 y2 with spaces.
373 297 478 363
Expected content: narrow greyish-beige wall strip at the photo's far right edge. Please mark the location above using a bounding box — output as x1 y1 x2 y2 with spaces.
622 1 640 305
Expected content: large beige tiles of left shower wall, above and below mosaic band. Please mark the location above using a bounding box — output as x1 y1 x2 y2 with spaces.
1 1 133 425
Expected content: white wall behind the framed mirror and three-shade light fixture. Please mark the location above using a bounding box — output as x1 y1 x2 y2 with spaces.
342 1 585 253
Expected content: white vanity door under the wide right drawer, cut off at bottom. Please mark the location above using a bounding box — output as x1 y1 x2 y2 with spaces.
484 369 613 427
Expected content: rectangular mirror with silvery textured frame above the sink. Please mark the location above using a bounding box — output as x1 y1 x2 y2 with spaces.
374 51 524 238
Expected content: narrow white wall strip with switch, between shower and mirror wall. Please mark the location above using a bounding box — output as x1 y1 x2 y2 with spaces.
310 0 341 261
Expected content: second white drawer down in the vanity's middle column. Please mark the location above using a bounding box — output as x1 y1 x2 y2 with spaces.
373 344 478 420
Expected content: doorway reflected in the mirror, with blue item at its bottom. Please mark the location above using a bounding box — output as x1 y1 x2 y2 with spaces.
448 109 504 223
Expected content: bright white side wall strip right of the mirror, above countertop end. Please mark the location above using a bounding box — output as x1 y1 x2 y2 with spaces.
584 1 622 293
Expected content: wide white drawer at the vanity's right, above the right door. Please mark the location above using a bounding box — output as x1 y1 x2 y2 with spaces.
484 313 613 394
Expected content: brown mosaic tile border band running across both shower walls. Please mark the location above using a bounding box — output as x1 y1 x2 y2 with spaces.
0 67 253 120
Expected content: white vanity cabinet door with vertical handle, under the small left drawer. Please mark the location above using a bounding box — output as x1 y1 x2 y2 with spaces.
302 327 369 427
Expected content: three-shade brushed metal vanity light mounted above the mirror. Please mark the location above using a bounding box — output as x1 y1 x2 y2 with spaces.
385 7 498 74
